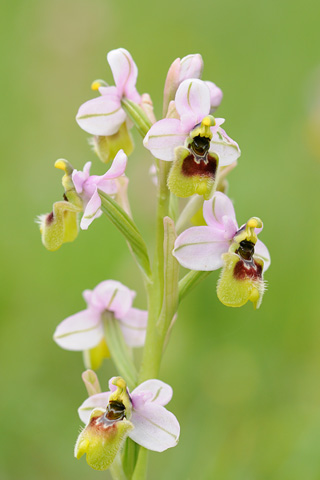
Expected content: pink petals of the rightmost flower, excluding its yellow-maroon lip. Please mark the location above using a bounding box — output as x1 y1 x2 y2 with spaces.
173 192 270 271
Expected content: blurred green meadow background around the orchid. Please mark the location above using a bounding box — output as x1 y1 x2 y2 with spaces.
0 0 320 480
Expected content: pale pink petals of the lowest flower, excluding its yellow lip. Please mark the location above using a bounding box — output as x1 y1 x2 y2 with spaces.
78 377 180 452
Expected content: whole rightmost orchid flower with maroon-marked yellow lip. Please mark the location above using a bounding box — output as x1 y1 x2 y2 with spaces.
173 192 270 308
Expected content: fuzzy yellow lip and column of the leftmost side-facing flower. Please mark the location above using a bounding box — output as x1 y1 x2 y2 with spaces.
37 159 82 252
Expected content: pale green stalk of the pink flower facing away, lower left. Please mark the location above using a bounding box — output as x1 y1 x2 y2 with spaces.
103 311 138 390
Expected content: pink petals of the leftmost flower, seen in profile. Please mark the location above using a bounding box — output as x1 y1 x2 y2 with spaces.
72 150 127 230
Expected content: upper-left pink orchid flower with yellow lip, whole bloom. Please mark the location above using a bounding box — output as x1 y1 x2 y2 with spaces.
76 48 141 162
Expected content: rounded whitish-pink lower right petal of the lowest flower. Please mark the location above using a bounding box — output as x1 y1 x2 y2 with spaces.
129 403 180 452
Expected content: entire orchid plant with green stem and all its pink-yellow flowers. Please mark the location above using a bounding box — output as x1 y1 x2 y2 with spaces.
38 48 270 480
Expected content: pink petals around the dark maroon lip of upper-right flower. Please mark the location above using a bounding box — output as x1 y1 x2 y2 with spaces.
143 79 240 163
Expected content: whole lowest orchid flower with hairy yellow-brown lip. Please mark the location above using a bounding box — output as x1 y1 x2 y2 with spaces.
75 377 180 470
